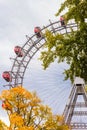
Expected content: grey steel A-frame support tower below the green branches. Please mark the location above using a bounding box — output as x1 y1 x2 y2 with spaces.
63 77 87 130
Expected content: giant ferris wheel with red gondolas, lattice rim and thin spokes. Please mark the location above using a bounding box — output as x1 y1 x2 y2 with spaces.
2 19 78 114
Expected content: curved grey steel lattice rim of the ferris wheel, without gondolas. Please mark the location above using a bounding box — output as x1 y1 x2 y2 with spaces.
5 21 77 87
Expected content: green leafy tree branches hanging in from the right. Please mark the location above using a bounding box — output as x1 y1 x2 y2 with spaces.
40 0 87 82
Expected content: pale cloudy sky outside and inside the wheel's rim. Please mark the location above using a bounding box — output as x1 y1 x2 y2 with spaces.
0 0 70 126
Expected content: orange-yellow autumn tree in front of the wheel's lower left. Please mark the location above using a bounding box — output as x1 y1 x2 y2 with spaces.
0 86 69 130
